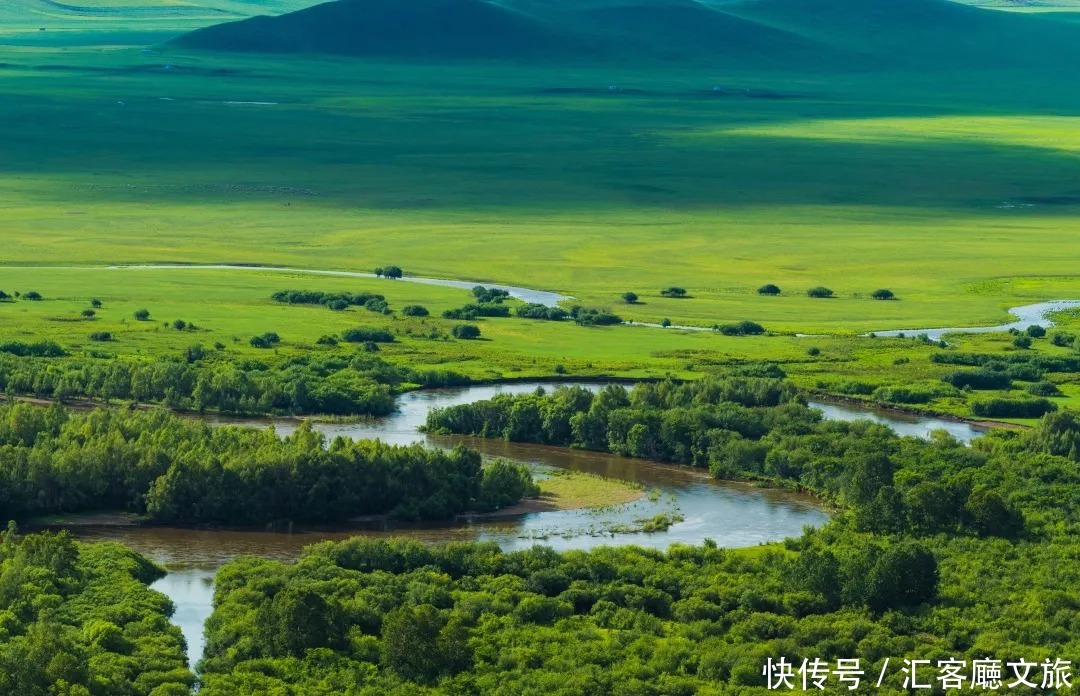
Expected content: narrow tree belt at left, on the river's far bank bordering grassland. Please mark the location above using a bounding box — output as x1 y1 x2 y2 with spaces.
0 350 469 415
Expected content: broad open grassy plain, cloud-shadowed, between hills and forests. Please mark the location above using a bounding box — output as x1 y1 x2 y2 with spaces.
0 9 1080 423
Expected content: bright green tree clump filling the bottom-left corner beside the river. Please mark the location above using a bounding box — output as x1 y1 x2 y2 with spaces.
0 525 194 696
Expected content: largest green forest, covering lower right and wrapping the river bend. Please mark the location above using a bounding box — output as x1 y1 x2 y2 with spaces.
185 378 1080 696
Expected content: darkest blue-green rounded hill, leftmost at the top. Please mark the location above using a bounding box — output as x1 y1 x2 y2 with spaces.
179 0 580 59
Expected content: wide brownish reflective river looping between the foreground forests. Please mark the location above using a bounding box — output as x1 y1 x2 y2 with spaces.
59 383 982 665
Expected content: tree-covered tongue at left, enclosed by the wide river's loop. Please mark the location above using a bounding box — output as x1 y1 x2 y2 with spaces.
0 403 535 524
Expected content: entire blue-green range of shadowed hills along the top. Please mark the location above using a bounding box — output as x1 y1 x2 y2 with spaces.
176 0 1080 70
